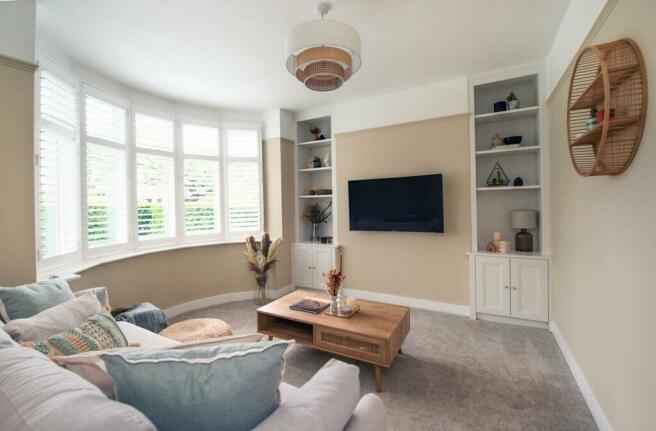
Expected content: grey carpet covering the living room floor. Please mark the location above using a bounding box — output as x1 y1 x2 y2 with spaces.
173 301 597 431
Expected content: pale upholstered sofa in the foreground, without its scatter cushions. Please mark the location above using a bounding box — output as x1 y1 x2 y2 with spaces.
0 286 386 431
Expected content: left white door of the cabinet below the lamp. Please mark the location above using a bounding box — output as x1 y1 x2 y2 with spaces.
476 256 510 316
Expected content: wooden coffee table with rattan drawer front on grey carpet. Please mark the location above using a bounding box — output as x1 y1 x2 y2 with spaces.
257 290 410 392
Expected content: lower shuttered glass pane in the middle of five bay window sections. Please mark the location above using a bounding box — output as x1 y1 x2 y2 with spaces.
137 154 175 240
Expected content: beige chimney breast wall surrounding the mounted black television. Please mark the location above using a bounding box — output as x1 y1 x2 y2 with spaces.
335 115 470 305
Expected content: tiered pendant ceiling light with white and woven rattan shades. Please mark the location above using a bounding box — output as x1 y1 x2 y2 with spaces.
286 3 360 91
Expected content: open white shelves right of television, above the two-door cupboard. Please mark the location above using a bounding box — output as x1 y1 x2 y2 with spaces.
470 70 545 253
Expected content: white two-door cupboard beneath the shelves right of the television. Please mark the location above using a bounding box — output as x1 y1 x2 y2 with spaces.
474 255 549 322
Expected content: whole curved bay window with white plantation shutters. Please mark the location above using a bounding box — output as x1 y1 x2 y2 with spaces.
36 69 262 276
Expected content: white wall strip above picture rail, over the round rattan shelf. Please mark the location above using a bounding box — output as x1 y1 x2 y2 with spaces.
546 0 617 97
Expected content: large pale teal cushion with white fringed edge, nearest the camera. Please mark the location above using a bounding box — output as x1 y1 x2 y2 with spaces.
101 341 290 431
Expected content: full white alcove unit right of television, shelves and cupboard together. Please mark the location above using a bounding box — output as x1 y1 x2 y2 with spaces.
468 66 550 328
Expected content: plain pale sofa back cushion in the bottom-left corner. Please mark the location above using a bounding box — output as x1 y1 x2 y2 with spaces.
0 347 156 431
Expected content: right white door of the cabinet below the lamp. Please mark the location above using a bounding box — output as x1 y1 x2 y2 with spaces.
510 258 549 322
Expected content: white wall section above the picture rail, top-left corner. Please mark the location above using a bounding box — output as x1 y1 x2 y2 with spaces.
0 0 36 63
